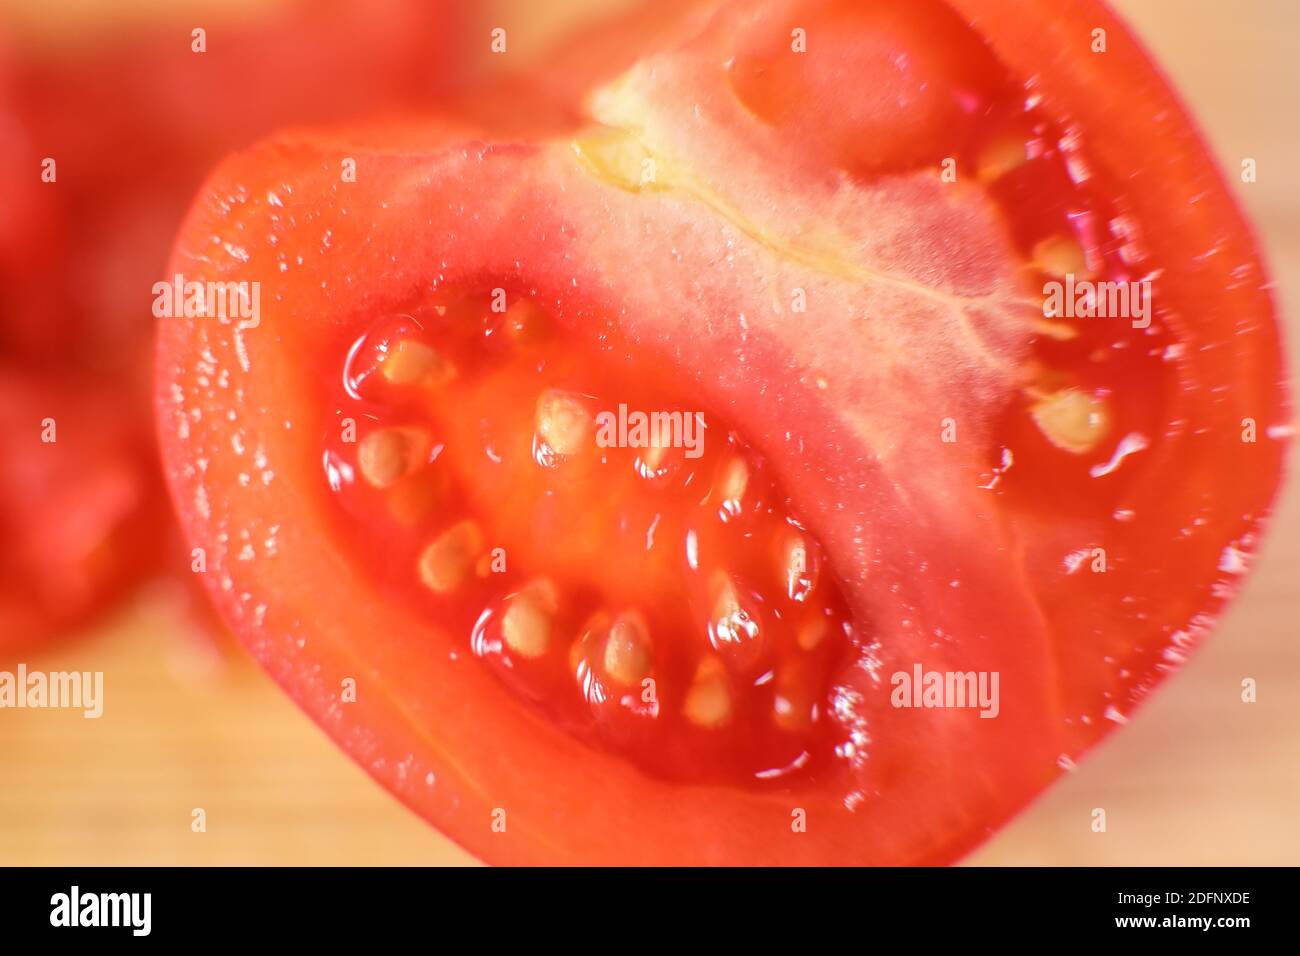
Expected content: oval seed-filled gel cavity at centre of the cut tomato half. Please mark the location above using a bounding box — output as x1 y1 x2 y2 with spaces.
322 300 852 786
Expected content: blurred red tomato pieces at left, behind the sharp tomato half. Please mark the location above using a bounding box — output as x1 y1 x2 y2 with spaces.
0 0 464 655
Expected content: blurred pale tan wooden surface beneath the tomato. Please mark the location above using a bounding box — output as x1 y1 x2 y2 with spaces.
0 0 1300 864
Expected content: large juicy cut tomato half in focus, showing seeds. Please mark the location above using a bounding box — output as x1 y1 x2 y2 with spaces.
155 0 1288 864
